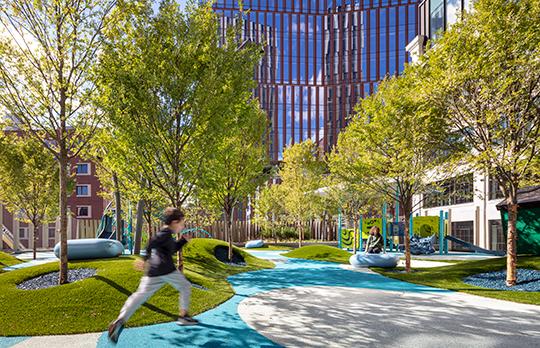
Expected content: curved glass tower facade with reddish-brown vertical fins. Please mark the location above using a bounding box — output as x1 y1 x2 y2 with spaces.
214 0 418 161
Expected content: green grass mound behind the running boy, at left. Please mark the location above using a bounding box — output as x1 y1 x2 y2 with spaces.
0 239 273 336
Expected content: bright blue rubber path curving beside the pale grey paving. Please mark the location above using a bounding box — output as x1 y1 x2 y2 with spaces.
0 251 447 348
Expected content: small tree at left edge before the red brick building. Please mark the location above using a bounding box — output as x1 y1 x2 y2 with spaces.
0 133 58 259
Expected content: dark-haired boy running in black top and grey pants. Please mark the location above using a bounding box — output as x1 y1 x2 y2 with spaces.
109 208 198 343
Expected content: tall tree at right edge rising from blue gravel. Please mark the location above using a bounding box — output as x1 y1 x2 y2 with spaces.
422 0 540 286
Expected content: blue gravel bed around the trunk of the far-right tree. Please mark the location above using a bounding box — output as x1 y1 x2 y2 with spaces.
463 268 540 291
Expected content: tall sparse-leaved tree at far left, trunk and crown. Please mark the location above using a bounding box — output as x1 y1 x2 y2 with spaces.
0 0 116 284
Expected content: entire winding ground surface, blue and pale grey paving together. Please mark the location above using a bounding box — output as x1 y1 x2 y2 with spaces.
0 251 540 348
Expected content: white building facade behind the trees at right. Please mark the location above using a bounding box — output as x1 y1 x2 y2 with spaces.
407 0 506 250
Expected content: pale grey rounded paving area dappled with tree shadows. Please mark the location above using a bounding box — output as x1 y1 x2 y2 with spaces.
238 286 540 348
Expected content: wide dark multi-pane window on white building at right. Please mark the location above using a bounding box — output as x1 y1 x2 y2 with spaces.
423 174 474 208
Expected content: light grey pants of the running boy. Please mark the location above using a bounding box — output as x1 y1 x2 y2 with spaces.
118 270 191 322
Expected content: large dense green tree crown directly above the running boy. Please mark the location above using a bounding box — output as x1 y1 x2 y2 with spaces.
95 0 258 206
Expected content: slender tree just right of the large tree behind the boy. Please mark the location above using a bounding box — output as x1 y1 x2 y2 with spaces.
200 99 267 260
